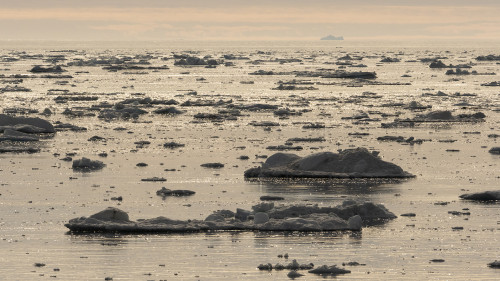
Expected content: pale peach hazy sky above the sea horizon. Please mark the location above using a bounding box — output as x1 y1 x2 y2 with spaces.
0 0 500 40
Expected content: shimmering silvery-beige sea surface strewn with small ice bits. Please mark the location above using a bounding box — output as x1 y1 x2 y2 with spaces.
0 41 500 280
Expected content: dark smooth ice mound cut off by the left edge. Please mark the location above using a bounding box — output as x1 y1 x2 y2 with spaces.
0 114 55 134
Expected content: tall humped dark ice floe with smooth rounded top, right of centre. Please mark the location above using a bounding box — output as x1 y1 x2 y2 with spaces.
245 148 414 178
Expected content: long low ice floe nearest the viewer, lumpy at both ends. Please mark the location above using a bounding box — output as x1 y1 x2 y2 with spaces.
65 201 396 233
